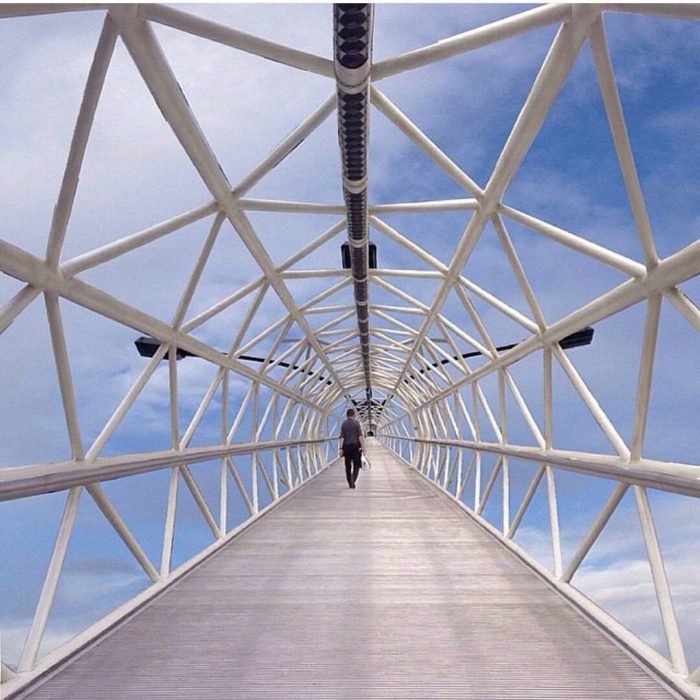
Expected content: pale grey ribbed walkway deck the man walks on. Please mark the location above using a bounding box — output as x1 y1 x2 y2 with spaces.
20 443 670 700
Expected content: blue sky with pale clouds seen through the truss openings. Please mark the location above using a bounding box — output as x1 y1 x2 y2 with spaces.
0 4 700 676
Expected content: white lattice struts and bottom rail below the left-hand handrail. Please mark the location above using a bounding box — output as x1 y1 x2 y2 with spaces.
2 438 331 698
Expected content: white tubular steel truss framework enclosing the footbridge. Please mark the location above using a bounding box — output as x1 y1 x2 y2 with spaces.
0 4 700 697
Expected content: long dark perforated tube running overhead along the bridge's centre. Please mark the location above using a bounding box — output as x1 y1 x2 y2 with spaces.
333 4 373 426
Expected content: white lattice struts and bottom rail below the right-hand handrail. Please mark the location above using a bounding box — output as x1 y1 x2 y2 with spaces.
380 433 700 700
